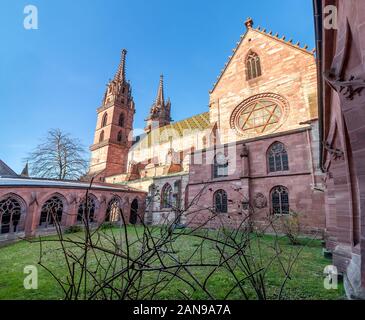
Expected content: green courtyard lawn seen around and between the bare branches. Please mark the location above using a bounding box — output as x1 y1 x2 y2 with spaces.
0 227 344 300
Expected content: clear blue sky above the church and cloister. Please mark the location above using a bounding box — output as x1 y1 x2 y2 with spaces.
0 0 314 172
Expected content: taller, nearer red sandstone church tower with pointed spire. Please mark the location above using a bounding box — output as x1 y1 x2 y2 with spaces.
89 49 135 181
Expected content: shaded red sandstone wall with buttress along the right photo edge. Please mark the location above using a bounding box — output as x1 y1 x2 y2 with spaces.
314 0 365 298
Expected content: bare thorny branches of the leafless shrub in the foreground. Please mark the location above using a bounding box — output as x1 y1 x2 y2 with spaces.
26 181 316 300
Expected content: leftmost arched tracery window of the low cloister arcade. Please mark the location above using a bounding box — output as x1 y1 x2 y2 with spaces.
0 197 21 234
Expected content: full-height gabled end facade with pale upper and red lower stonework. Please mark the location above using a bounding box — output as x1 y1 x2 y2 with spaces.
187 19 325 237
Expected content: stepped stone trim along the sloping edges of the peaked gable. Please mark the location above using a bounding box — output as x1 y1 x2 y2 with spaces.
209 18 316 93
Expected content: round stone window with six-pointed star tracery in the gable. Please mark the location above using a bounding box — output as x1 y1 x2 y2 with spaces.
231 95 287 137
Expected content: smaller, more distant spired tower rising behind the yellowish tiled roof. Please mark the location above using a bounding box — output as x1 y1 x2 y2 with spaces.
145 75 171 133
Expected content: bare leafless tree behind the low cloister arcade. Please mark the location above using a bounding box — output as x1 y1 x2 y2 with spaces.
26 129 88 180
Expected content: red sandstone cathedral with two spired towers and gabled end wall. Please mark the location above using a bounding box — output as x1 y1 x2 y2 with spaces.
88 18 325 233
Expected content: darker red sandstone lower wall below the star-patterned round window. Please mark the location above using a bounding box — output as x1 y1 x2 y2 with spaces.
188 128 325 232
